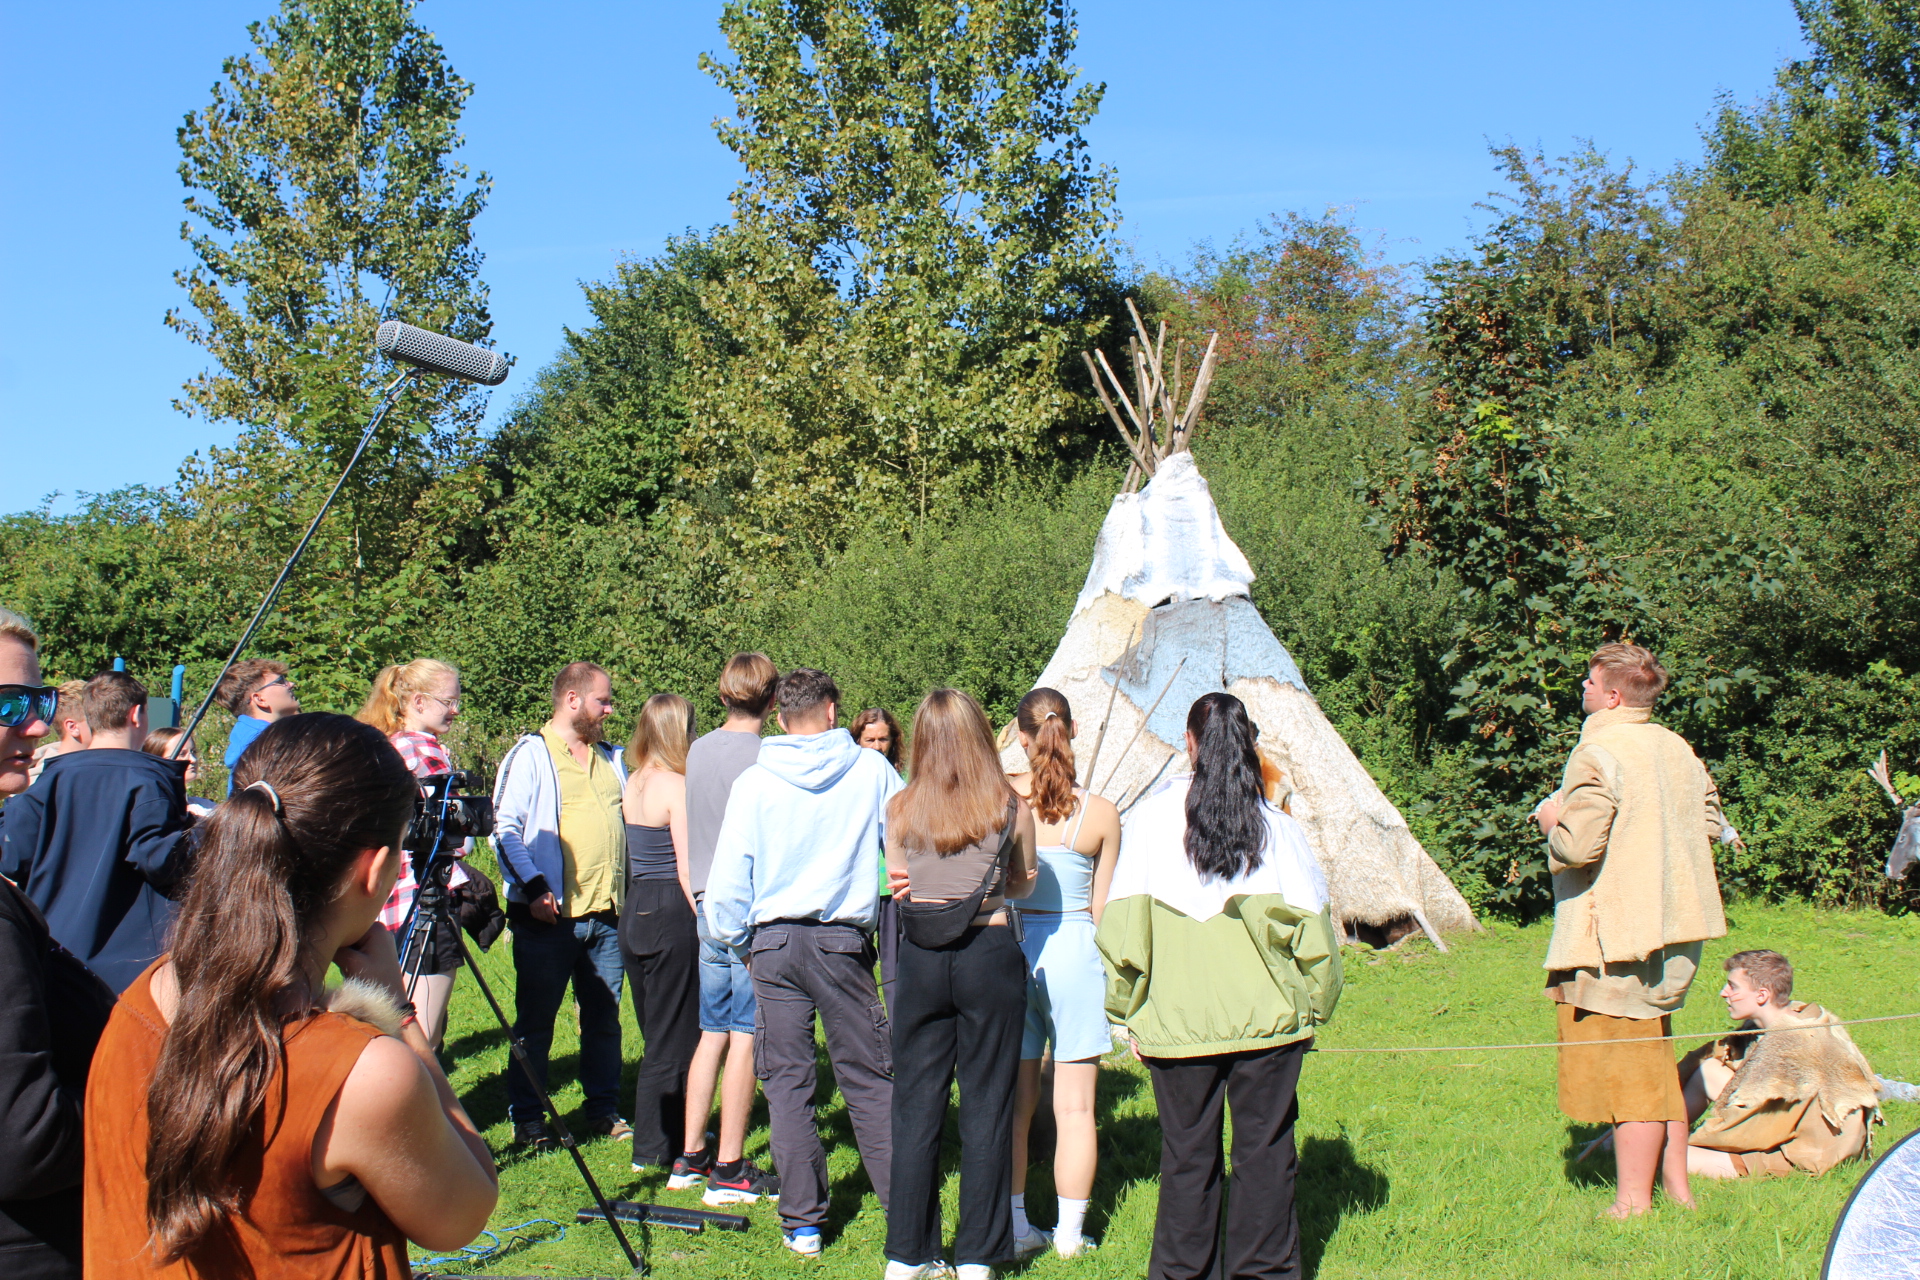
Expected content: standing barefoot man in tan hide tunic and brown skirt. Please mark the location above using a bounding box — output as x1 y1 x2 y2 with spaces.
1534 645 1726 1219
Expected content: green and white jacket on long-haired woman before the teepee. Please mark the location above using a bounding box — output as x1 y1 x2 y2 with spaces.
1096 777 1340 1057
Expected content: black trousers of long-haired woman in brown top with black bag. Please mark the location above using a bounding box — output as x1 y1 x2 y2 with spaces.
887 925 1027 1267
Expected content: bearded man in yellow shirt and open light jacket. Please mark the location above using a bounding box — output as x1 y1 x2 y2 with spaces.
493 662 634 1150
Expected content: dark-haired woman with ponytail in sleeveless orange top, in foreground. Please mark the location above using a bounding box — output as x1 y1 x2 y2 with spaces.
84 714 497 1280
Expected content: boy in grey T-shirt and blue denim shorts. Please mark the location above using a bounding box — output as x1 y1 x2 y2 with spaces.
664 652 780 1205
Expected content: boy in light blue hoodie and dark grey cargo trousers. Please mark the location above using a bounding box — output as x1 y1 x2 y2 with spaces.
707 668 902 1257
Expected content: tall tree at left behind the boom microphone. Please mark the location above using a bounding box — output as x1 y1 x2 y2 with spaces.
167 0 490 699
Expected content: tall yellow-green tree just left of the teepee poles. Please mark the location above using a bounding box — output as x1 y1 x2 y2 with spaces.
687 0 1117 551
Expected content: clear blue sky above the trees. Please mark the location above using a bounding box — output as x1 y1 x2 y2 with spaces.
0 0 1801 512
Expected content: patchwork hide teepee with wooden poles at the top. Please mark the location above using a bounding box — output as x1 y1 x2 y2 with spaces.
1002 301 1478 950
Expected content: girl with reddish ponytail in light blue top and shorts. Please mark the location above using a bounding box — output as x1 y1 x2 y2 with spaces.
1012 689 1119 1257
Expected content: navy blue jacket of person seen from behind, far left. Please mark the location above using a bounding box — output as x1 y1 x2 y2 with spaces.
0 747 192 992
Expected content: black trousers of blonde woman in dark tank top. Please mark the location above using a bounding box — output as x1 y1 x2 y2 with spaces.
620 879 701 1165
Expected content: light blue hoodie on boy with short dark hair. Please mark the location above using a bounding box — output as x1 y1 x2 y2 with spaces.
705 729 904 954
